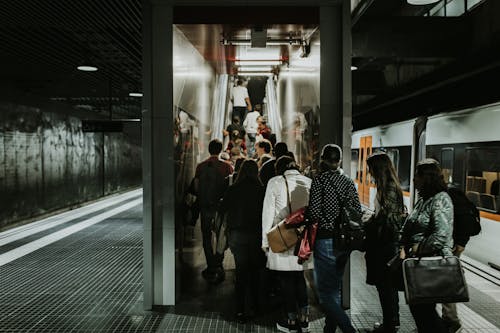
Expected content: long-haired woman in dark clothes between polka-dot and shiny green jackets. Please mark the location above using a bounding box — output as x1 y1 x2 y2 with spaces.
365 153 406 333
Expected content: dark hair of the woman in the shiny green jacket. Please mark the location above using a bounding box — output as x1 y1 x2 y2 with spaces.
415 158 446 200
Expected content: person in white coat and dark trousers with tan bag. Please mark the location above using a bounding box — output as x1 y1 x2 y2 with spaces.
262 156 312 333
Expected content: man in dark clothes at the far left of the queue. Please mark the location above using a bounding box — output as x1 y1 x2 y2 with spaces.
195 139 233 283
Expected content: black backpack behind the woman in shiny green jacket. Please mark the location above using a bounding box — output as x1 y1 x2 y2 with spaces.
448 188 481 238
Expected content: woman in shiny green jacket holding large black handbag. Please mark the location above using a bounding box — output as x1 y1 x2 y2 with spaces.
400 159 453 333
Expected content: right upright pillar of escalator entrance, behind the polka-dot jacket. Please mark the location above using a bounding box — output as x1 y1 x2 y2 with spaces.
319 0 352 308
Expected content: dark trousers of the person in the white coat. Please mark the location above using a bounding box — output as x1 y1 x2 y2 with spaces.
275 271 309 315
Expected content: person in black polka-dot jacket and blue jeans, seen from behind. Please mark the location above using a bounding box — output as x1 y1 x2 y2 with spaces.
307 144 362 333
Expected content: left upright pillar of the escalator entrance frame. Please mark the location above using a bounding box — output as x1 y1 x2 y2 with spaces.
142 0 175 309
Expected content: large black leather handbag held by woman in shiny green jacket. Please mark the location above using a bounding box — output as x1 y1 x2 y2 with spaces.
403 256 469 304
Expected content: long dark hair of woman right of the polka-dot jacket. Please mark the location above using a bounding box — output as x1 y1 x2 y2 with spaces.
366 153 402 208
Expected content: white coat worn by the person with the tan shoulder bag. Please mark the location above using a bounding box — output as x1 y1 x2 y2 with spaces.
262 170 312 271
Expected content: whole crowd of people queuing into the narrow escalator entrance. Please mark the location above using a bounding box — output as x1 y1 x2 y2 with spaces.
188 80 463 333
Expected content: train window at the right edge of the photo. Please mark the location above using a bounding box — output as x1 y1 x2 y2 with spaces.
465 147 500 213
